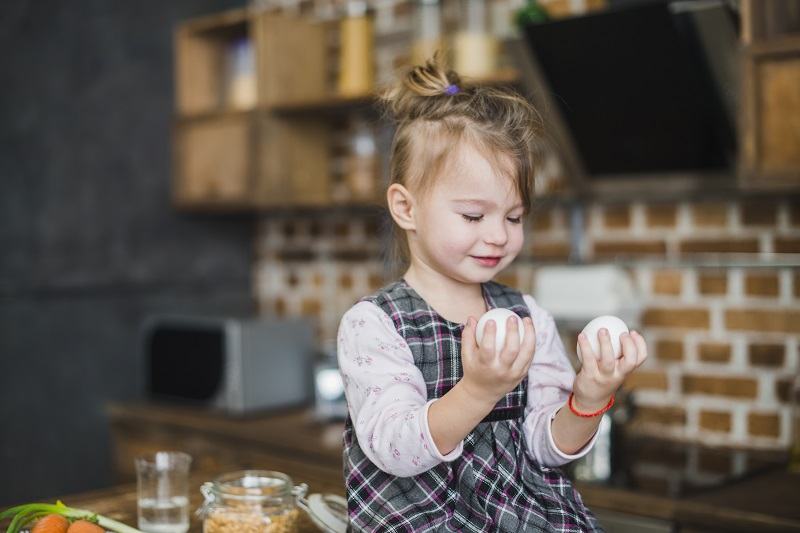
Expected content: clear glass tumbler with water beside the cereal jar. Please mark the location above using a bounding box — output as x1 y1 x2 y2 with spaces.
135 452 192 533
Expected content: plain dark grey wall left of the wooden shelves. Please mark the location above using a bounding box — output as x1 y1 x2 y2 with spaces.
0 0 254 503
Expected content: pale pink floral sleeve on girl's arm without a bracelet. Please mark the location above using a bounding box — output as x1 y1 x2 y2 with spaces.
337 302 463 477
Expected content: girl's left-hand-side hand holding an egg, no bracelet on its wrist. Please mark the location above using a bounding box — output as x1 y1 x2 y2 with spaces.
461 317 536 404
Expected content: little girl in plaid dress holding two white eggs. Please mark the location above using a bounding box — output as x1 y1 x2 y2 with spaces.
338 60 647 533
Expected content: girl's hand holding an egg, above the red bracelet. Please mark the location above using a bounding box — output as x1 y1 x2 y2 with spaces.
572 328 647 412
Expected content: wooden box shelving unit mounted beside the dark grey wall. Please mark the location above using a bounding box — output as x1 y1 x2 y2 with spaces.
173 9 518 211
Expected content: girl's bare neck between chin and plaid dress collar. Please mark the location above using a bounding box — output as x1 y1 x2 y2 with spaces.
403 264 486 324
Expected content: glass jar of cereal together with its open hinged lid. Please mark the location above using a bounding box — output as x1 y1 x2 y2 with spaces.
197 470 347 533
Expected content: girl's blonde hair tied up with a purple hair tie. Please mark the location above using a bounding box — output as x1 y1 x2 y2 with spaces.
381 53 544 270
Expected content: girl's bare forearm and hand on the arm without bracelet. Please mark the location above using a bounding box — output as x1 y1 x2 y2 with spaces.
428 317 536 453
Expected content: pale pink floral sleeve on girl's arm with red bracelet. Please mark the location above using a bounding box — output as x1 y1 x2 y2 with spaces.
523 294 597 466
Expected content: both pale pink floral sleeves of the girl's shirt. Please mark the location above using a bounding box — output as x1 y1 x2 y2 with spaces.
337 295 597 477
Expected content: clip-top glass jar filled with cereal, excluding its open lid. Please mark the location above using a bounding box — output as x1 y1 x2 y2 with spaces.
198 470 306 533
